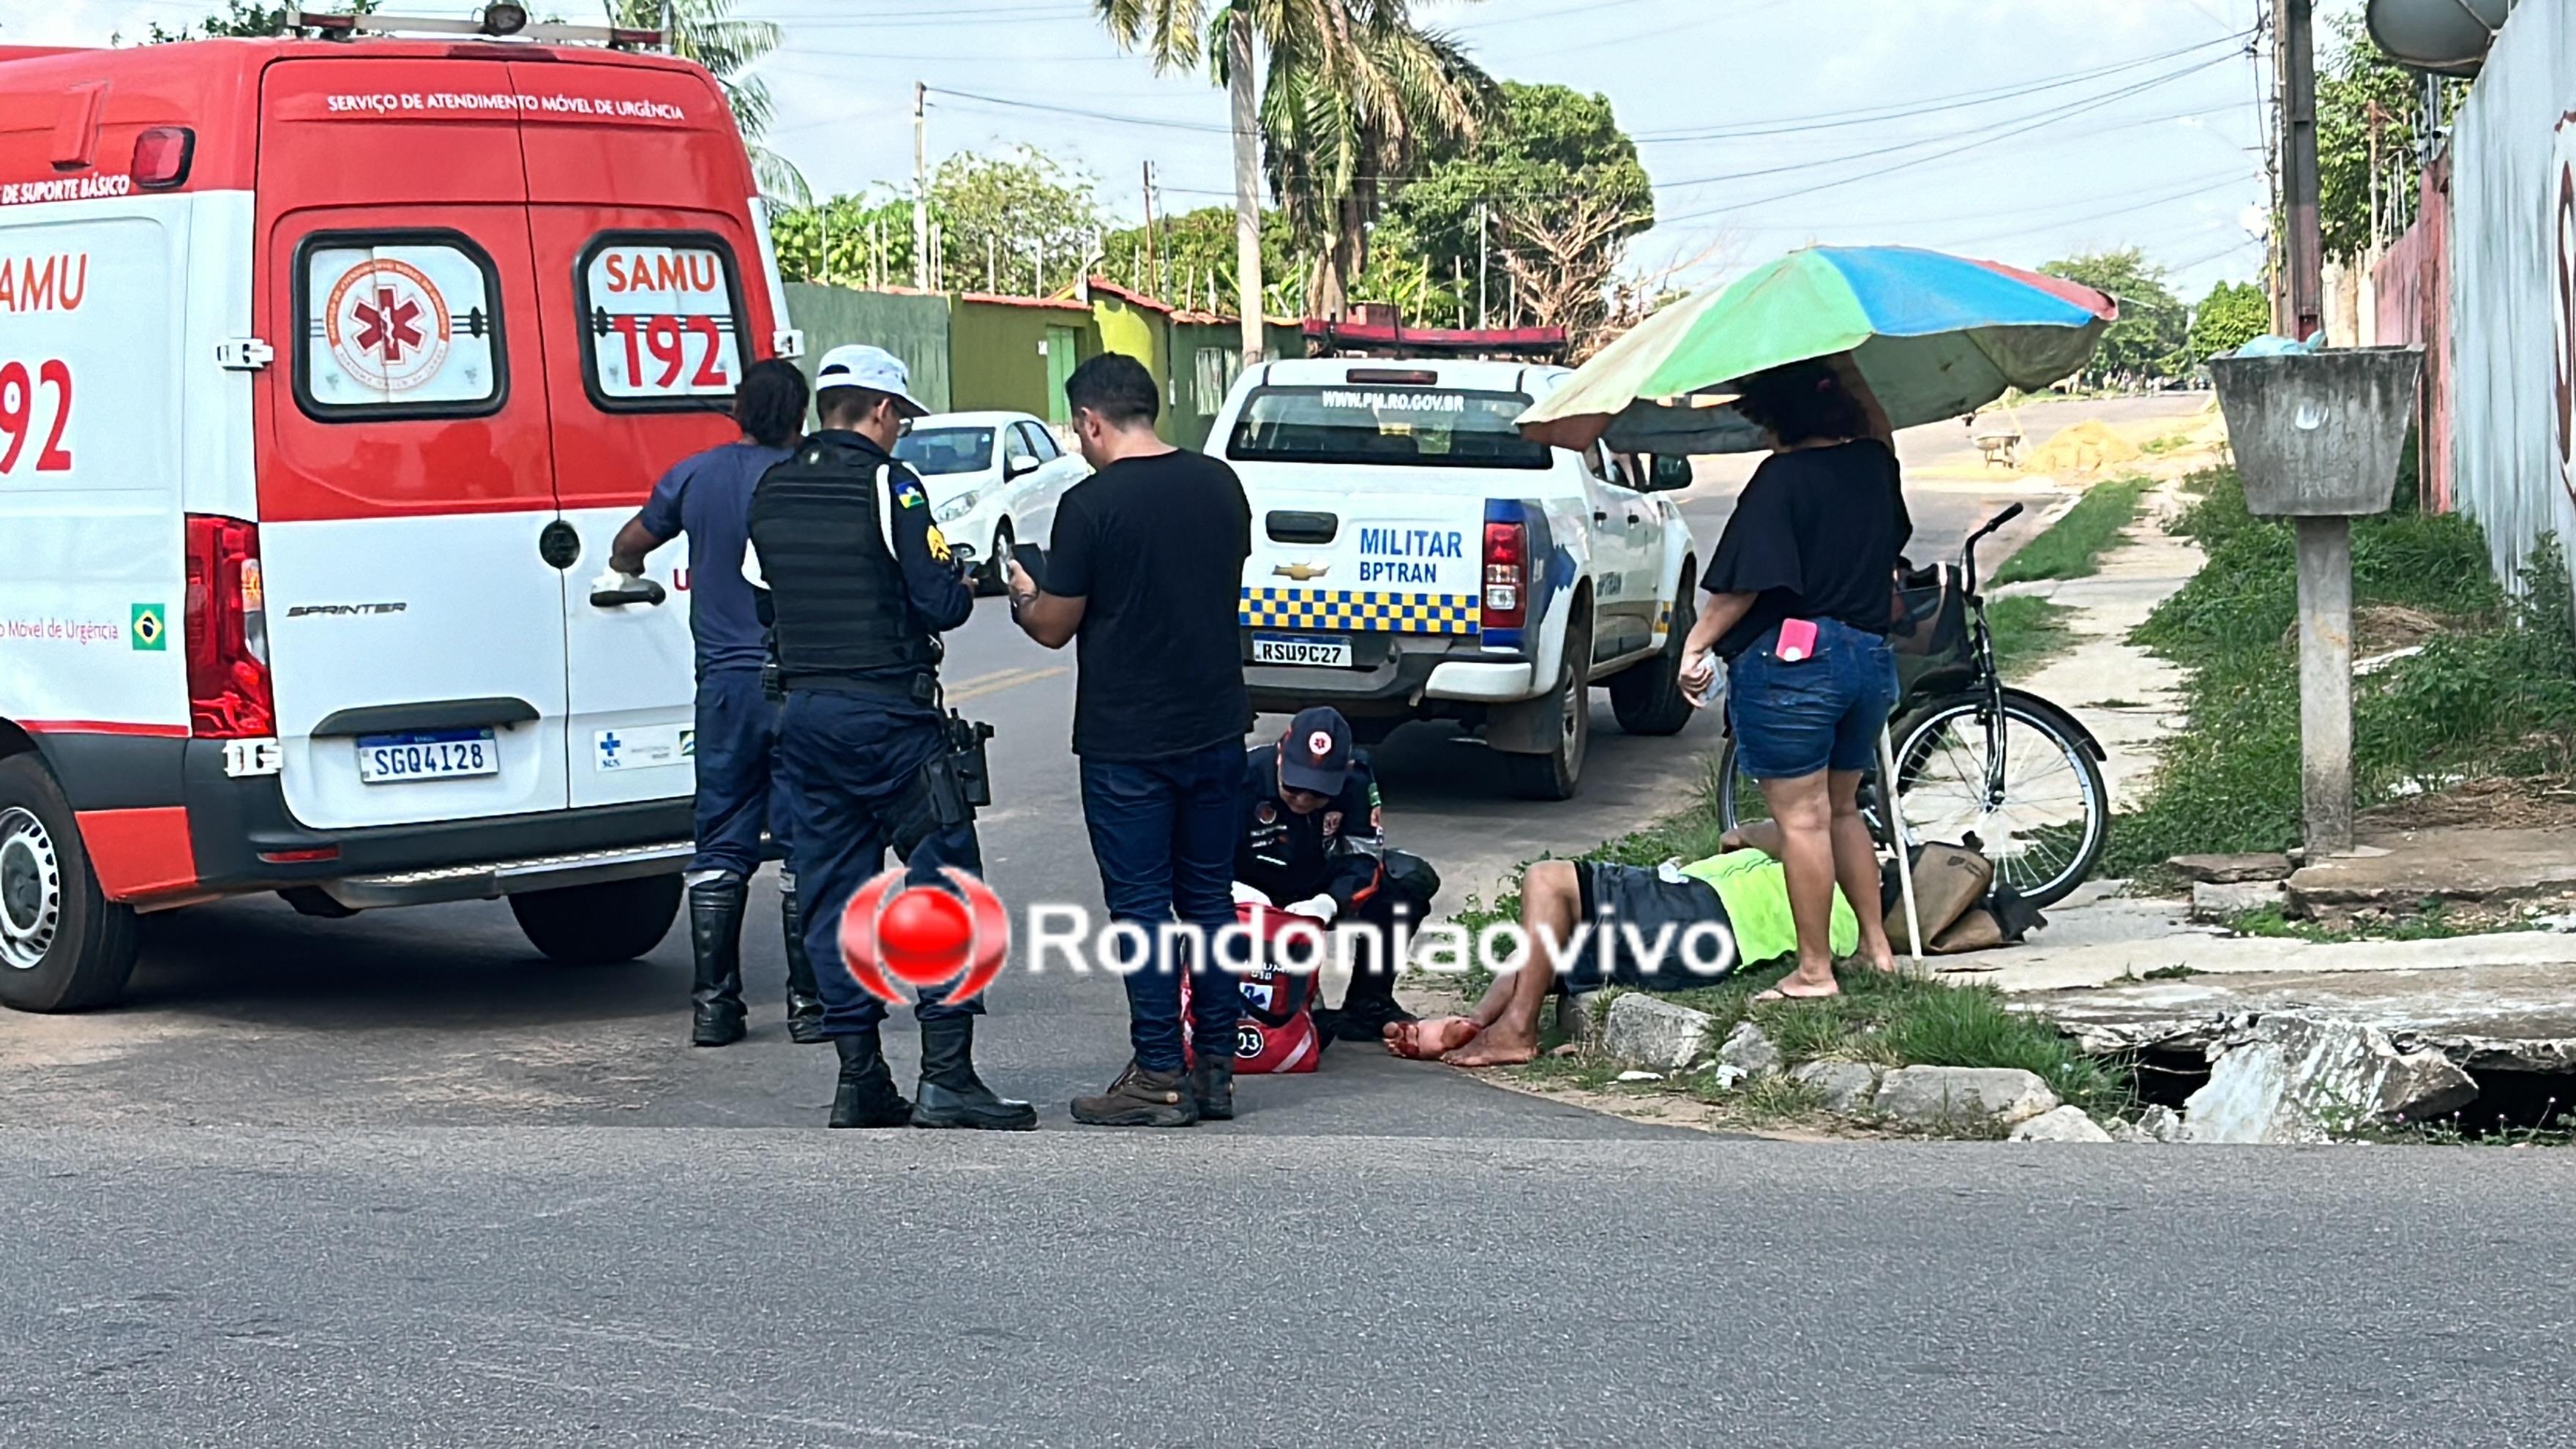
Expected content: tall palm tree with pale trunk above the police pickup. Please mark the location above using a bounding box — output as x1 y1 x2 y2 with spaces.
1092 0 1499 332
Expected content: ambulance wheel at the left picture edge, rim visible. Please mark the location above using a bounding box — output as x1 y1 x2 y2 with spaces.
0 753 142 1011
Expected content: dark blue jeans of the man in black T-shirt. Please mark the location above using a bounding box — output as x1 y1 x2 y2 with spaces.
1082 740 1244 1073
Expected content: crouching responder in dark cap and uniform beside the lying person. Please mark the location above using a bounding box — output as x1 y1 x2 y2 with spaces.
1234 706 1440 1041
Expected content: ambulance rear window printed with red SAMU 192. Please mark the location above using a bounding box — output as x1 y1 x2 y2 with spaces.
580 232 742 413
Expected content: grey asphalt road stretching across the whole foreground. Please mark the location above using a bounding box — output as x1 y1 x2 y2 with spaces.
0 1129 2576 1449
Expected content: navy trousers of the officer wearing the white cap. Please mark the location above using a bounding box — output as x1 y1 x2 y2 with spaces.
778 691 984 1036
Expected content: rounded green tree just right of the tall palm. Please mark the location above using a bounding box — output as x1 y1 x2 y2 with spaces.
1378 80 1654 335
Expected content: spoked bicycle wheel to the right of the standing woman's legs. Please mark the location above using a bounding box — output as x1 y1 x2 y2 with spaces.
1893 696 2110 905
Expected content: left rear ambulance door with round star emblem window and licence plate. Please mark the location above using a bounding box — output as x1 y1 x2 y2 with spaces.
255 54 569 830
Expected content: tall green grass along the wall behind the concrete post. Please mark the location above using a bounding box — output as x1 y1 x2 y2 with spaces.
2105 469 2576 874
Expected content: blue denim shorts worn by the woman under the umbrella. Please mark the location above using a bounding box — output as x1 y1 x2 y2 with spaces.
1726 619 1896 779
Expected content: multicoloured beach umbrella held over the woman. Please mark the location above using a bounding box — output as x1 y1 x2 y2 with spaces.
1520 247 2120 454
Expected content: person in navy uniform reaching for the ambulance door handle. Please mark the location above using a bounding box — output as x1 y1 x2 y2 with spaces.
598 359 822 1046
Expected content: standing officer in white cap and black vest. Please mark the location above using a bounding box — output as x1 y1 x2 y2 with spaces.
749 345 1038 1129
